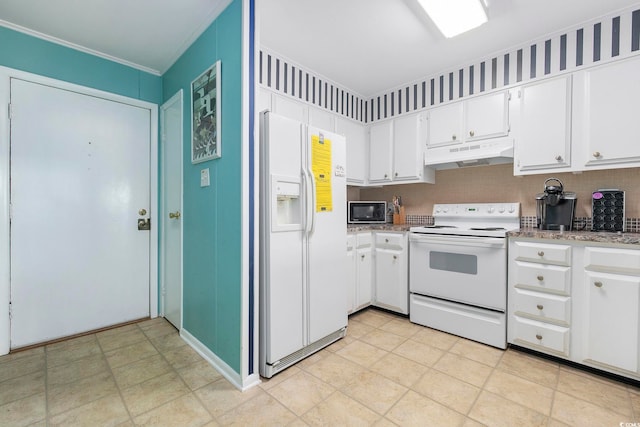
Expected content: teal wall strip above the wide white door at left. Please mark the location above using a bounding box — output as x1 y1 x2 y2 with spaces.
0 27 162 104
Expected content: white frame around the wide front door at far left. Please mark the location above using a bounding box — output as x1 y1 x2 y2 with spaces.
0 67 158 355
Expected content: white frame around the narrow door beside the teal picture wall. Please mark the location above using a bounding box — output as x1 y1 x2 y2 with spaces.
159 89 184 329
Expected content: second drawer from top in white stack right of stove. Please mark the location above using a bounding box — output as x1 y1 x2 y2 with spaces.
513 262 571 295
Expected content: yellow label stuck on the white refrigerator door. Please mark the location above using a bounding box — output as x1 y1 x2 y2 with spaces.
311 135 333 212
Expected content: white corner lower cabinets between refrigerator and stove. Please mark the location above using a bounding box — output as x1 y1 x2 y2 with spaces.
347 231 409 314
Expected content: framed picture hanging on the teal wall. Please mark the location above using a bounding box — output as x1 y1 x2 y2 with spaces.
191 61 222 163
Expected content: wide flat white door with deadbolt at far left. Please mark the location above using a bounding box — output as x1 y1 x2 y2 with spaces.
10 79 151 348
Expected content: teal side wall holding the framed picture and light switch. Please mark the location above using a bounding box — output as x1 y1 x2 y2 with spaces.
162 0 242 373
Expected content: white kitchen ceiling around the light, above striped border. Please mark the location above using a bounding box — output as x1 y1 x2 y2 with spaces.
256 0 640 97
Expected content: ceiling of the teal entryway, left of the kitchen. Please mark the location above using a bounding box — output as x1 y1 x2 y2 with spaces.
0 0 231 74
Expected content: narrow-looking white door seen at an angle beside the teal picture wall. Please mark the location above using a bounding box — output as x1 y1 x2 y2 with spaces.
160 91 182 329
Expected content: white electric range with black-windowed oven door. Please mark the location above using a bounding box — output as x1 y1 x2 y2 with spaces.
409 202 520 348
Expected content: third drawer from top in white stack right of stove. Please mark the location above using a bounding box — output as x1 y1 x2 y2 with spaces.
512 289 571 326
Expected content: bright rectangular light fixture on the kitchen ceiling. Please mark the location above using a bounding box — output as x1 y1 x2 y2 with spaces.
418 0 487 38
